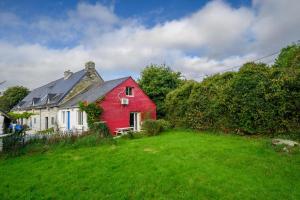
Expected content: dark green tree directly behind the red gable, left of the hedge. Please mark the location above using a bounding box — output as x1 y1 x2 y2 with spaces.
138 65 182 117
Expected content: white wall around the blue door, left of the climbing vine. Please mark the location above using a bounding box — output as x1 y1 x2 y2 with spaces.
57 108 88 132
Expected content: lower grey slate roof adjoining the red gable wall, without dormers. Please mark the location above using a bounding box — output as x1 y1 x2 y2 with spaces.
62 77 130 108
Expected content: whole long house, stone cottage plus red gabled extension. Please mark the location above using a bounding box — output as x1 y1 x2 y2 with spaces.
13 62 156 134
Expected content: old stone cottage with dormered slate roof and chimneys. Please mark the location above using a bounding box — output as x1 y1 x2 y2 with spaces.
12 62 104 131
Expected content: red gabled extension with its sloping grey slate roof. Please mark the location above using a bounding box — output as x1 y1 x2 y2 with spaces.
64 77 156 135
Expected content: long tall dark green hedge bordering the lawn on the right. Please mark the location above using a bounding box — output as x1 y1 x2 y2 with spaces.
165 58 300 134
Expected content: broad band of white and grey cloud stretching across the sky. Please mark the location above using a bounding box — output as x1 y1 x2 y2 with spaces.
0 0 300 88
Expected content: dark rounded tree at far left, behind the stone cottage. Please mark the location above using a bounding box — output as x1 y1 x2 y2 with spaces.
0 86 29 112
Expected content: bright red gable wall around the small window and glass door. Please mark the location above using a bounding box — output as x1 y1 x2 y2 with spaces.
100 78 156 134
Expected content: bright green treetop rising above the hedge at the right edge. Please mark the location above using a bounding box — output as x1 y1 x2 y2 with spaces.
274 44 300 68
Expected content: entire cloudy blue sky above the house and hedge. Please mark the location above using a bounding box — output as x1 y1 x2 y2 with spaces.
0 0 300 90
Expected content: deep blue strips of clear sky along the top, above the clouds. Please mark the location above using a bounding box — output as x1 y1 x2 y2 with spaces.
0 0 251 23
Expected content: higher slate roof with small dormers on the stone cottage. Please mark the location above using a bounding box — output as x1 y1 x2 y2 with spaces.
13 69 86 110
